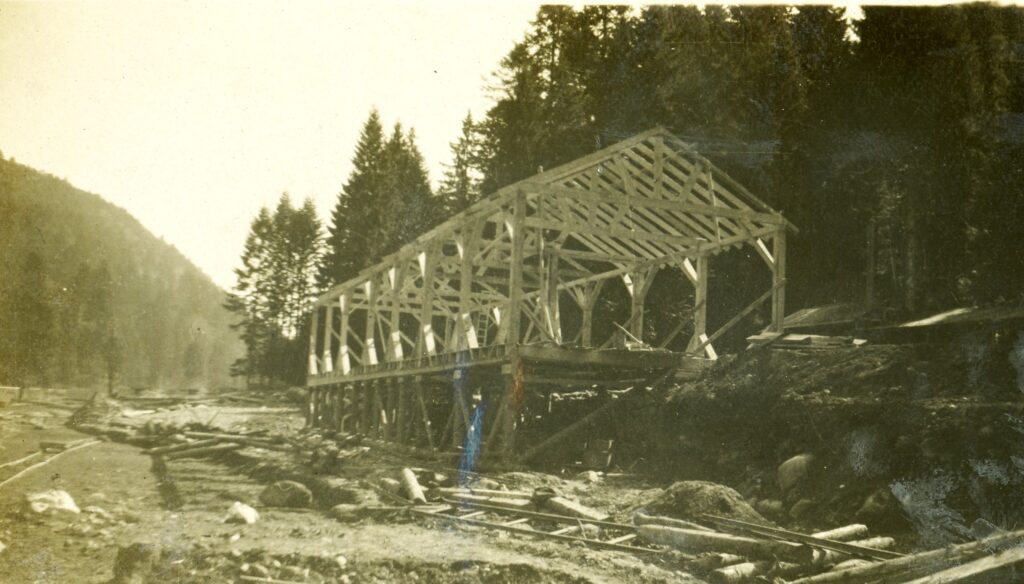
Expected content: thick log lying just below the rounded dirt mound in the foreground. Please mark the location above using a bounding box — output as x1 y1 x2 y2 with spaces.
637 526 813 564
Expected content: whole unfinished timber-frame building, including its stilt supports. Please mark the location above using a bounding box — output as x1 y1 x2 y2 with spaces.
306 128 796 458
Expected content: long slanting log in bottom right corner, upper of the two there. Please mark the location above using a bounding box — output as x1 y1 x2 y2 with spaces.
791 531 1024 584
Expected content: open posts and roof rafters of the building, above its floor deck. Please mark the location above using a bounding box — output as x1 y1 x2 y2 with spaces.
308 128 796 386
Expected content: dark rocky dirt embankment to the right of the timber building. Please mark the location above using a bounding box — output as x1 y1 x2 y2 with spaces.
623 337 1024 547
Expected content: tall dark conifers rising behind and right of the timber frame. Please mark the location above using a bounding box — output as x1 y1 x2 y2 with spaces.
232 4 1024 381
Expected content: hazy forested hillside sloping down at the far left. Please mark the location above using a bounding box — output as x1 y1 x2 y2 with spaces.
0 154 242 389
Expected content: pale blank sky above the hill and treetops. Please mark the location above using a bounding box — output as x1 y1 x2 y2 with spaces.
0 1 537 288
